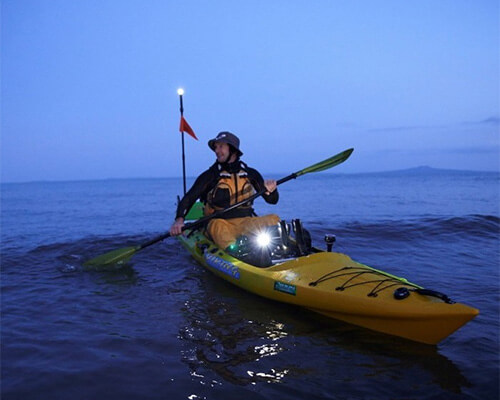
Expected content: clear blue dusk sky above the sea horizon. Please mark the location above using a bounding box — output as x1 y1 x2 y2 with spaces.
1 0 500 182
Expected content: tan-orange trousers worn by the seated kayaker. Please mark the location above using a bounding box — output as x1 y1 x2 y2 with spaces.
207 214 280 250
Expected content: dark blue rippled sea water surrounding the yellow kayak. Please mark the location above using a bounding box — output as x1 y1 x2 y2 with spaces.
1 172 500 400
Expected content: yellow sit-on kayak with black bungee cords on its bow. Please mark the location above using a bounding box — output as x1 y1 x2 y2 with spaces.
178 230 479 344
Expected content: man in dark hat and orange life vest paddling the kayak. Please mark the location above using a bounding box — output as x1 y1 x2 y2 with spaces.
170 132 279 250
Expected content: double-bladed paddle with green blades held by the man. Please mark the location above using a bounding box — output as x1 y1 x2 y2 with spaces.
83 149 354 267
